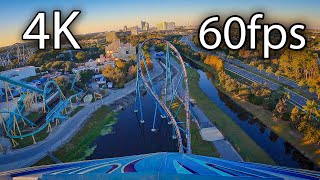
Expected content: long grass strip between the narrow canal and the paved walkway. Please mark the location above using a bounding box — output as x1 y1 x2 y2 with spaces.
187 62 275 164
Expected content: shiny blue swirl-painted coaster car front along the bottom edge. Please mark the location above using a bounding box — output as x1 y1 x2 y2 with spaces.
0 152 320 180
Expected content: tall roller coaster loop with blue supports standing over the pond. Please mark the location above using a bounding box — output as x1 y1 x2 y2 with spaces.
135 38 191 153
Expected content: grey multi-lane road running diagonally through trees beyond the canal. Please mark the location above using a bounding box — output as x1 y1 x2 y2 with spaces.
181 36 316 108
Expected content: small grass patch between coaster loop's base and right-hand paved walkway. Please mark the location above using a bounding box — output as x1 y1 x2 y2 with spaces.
171 101 220 157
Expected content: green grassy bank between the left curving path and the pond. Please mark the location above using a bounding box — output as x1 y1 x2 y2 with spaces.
54 105 117 162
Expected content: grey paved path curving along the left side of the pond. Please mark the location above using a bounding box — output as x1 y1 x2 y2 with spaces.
0 54 163 171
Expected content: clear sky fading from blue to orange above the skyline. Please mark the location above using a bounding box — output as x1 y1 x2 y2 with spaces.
0 0 320 47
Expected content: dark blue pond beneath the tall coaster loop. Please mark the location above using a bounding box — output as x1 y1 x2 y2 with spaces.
87 82 177 159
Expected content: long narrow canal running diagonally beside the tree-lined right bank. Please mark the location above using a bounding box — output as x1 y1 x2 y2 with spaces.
184 57 319 170
